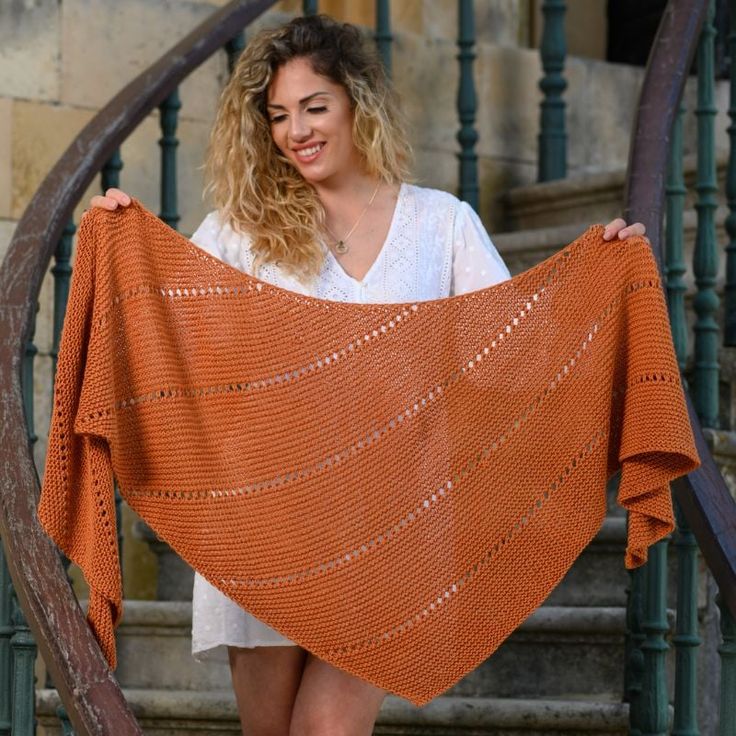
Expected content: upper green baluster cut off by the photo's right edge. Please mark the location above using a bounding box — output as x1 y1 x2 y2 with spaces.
723 0 736 347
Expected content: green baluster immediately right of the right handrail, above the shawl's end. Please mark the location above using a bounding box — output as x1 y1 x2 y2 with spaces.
664 105 688 371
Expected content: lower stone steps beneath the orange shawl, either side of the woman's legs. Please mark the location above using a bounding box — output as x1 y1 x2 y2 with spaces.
37 515 628 736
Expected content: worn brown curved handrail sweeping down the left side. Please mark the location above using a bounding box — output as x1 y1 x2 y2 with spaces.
0 0 276 736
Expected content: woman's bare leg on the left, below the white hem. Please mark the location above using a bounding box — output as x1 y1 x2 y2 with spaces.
228 646 307 736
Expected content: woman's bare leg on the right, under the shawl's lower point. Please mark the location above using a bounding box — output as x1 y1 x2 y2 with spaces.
284 653 387 736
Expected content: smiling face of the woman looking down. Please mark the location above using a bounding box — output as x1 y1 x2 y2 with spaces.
267 58 362 183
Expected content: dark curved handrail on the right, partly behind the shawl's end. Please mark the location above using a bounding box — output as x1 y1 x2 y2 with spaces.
624 0 736 616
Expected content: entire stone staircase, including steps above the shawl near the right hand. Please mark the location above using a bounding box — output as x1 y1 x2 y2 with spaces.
31 167 725 736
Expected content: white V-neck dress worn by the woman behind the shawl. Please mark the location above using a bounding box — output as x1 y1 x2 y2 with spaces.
191 184 510 661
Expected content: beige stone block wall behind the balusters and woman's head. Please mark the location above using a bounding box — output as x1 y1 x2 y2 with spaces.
0 0 656 255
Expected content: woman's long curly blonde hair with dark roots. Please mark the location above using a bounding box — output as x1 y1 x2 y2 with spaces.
204 15 411 282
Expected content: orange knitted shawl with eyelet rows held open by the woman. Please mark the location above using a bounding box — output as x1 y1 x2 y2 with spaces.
38 200 699 705
